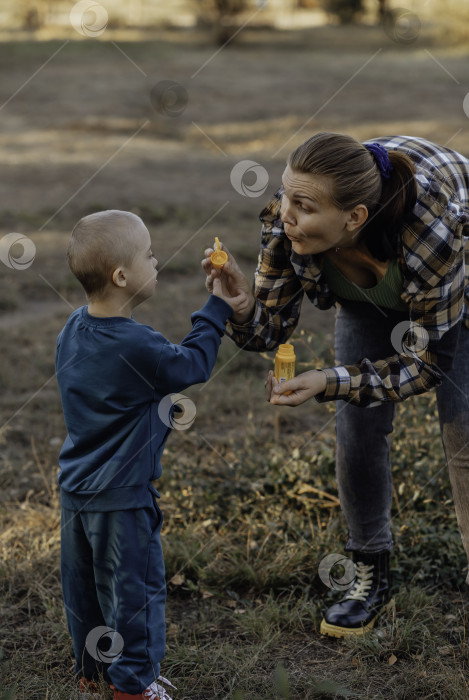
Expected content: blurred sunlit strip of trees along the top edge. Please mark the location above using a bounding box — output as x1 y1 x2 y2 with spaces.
0 0 469 44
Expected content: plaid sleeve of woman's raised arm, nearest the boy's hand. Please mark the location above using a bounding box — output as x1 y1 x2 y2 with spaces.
226 190 303 352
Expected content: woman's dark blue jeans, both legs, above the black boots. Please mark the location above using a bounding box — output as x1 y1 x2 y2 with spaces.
335 303 469 582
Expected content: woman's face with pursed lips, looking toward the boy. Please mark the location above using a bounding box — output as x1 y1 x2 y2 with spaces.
280 165 368 255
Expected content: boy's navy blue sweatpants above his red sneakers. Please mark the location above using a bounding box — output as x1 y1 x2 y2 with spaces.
61 501 166 694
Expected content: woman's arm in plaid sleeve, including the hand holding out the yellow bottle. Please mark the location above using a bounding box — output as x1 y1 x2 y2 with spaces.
266 197 469 407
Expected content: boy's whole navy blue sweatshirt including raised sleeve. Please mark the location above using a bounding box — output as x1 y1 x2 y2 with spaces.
55 296 233 511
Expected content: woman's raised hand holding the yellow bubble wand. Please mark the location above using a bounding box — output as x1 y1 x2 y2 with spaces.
202 243 255 323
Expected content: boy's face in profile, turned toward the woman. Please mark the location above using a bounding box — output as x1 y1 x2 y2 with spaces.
121 221 158 306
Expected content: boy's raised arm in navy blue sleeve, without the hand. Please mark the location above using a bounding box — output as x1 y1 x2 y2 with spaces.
154 295 233 396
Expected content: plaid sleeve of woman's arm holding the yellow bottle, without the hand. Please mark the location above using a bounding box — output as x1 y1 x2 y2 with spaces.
316 152 469 407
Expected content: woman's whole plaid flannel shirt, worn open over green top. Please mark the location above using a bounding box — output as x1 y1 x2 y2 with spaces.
227 136 469 406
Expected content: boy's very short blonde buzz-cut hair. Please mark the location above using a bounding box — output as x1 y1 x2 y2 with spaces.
67 209 141 299
